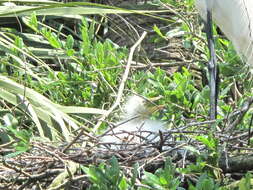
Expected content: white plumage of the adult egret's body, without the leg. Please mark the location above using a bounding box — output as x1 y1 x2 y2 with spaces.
196 0 253 66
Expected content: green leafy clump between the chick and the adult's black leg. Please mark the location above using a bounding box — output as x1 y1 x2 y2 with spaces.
129 67 209 125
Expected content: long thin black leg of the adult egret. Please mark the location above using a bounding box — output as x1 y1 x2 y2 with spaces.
206 9 218 120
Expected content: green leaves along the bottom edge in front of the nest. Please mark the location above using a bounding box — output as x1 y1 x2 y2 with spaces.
82 157 231 190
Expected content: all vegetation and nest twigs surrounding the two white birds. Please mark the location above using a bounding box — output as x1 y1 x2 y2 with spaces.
0 0 253 190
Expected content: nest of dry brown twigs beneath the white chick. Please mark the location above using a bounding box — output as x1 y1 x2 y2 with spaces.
0 119 253 190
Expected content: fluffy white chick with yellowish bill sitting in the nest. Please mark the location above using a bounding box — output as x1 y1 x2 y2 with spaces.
101 95 166 149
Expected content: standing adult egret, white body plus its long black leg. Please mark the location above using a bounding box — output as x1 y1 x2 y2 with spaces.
196 0 253 119
